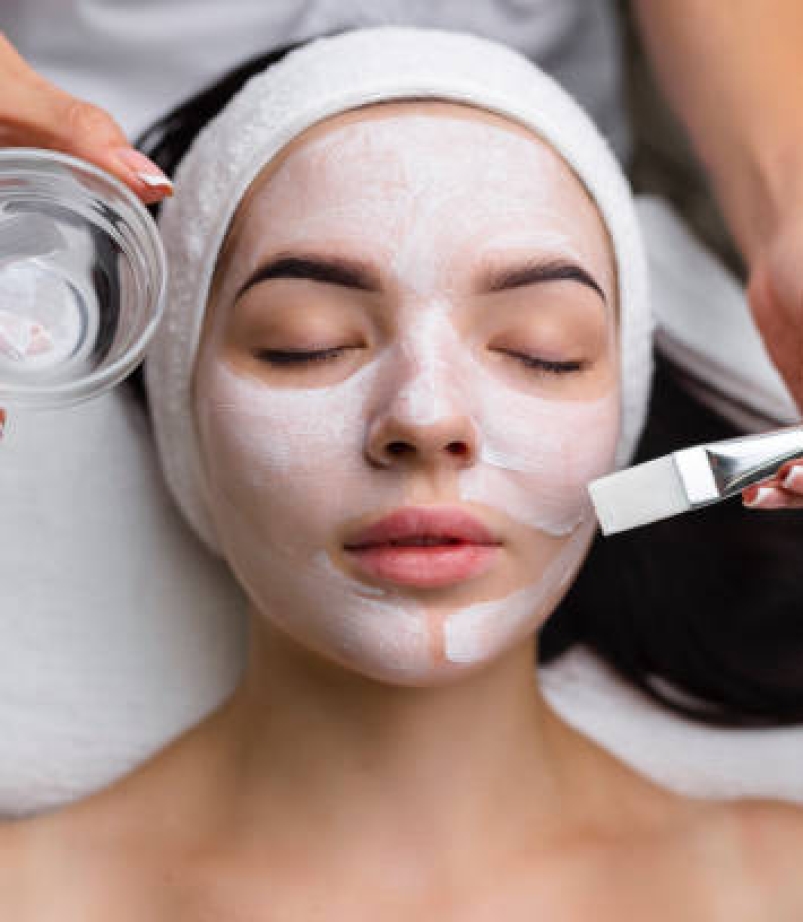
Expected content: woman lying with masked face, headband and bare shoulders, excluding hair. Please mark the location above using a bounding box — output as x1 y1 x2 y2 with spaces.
0 28 803 922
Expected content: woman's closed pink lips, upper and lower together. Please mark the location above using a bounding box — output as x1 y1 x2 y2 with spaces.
345 506 501 589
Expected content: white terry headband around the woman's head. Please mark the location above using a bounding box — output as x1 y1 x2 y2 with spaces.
145 27 652 551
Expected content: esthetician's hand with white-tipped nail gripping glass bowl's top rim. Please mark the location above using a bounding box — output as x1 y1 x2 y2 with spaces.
0 33 172 204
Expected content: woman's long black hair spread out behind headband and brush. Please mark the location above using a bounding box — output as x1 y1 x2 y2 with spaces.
133 39 803 726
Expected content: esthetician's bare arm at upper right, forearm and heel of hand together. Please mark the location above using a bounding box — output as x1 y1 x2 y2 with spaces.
633 0 803 409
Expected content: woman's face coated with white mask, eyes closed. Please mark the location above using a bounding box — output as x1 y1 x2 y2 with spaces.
194 102 619 685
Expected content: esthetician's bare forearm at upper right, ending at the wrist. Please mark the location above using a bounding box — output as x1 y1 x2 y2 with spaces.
633 0 803 262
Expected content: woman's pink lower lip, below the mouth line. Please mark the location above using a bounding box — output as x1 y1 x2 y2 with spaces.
348 544 499 589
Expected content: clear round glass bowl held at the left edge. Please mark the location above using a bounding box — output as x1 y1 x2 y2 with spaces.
0 148 166 408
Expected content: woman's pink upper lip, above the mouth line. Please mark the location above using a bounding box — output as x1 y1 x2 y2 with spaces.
345 506 501 550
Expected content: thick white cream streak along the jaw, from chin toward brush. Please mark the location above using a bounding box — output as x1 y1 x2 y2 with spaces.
444 526 590 663
